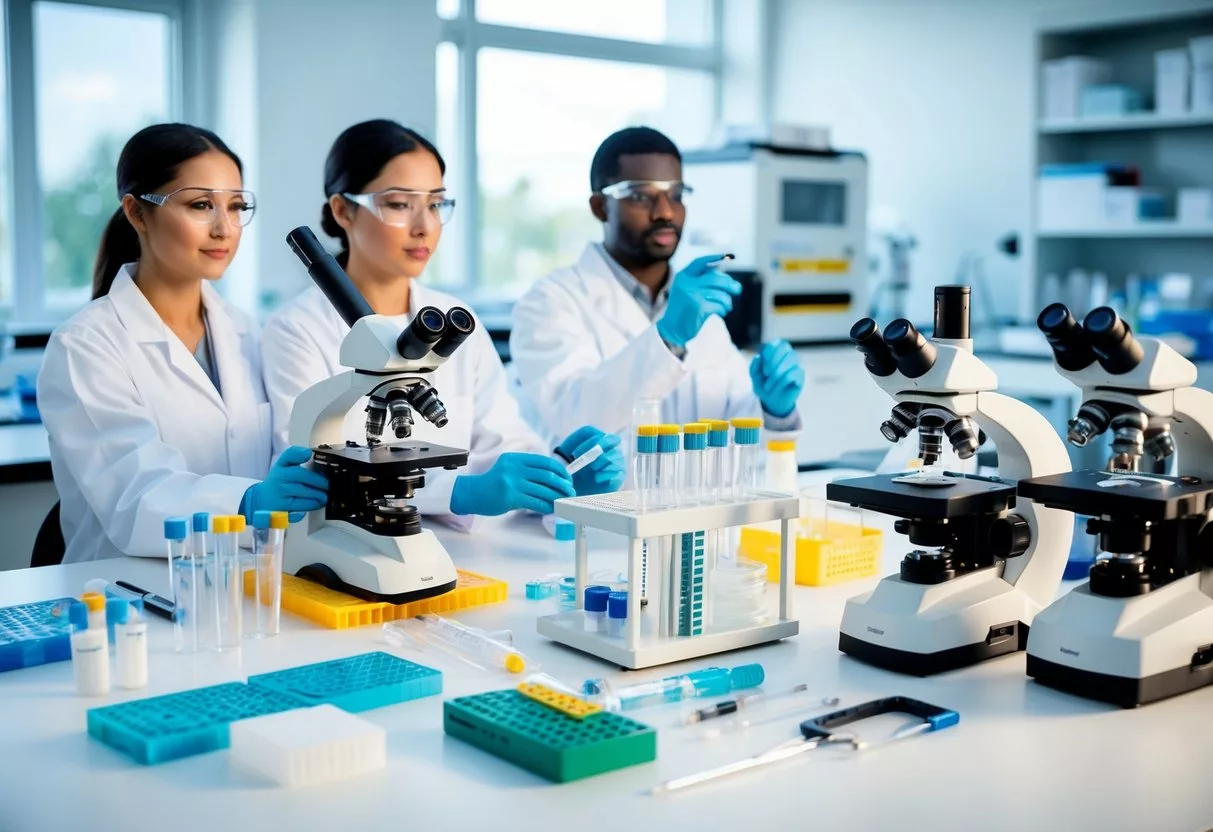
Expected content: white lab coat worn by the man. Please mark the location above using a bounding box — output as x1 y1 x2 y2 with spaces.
509 245 790 437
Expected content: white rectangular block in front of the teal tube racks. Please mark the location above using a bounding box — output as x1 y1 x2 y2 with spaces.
230 705 387 787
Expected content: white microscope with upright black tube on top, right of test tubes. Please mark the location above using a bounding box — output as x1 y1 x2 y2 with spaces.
826 286 1074 676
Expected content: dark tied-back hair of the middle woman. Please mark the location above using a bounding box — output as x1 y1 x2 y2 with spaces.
320 119 446 268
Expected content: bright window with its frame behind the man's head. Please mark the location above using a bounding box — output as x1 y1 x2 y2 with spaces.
431 0 719 297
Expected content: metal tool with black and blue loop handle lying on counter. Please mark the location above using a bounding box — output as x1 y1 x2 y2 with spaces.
653 696 961 794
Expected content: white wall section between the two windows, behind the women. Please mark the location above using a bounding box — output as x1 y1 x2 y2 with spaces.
212 0 439 309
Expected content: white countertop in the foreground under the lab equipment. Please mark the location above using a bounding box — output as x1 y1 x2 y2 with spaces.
0 489 1213 832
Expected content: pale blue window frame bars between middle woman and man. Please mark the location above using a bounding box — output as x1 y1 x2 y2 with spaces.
431 0 725 291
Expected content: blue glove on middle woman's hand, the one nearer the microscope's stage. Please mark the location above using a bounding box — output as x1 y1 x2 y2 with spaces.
451 454 576 517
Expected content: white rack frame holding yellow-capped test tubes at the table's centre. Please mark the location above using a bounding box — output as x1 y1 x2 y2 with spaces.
537 491 801 669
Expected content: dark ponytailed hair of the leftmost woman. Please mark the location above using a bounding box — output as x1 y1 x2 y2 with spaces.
92 124 244 300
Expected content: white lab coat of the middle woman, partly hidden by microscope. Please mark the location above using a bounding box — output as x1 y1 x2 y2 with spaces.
261 280 551 529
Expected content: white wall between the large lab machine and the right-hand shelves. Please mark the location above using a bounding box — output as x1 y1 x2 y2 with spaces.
774 0 1174 329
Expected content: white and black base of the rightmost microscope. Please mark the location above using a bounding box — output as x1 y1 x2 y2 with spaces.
1027 570 1213 708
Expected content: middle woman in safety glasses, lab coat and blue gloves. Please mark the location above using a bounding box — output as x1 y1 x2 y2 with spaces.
262 120 623 528
